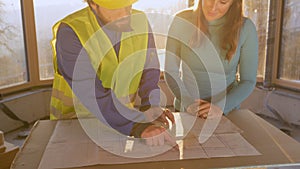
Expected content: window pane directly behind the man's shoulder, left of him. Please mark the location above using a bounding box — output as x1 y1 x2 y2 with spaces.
34 0 87 80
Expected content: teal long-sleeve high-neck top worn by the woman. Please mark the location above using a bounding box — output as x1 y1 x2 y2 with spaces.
165 9 258 115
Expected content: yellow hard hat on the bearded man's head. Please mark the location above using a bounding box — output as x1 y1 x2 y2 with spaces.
93 0 138 9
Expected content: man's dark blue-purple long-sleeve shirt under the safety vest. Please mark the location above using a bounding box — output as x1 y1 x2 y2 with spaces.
56 8 160 136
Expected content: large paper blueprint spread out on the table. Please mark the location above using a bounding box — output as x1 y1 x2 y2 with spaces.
39 113 260 169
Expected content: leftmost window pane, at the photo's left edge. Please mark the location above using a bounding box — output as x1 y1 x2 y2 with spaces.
0 0 28 89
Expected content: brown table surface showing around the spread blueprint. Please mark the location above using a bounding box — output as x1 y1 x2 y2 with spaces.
12 109 300 169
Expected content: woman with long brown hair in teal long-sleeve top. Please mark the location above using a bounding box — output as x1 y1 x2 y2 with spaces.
165 0 258 119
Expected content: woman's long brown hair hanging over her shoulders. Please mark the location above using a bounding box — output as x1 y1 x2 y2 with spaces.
191 0 244 61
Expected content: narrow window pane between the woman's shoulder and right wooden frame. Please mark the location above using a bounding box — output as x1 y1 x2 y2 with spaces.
243 0 270 81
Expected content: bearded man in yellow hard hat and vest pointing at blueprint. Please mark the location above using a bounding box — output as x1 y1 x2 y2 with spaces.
50 0 176 148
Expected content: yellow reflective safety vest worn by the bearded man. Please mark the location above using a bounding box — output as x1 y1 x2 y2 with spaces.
50 7 148 120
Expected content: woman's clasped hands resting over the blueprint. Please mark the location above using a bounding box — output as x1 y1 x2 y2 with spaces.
187 99 223 119
